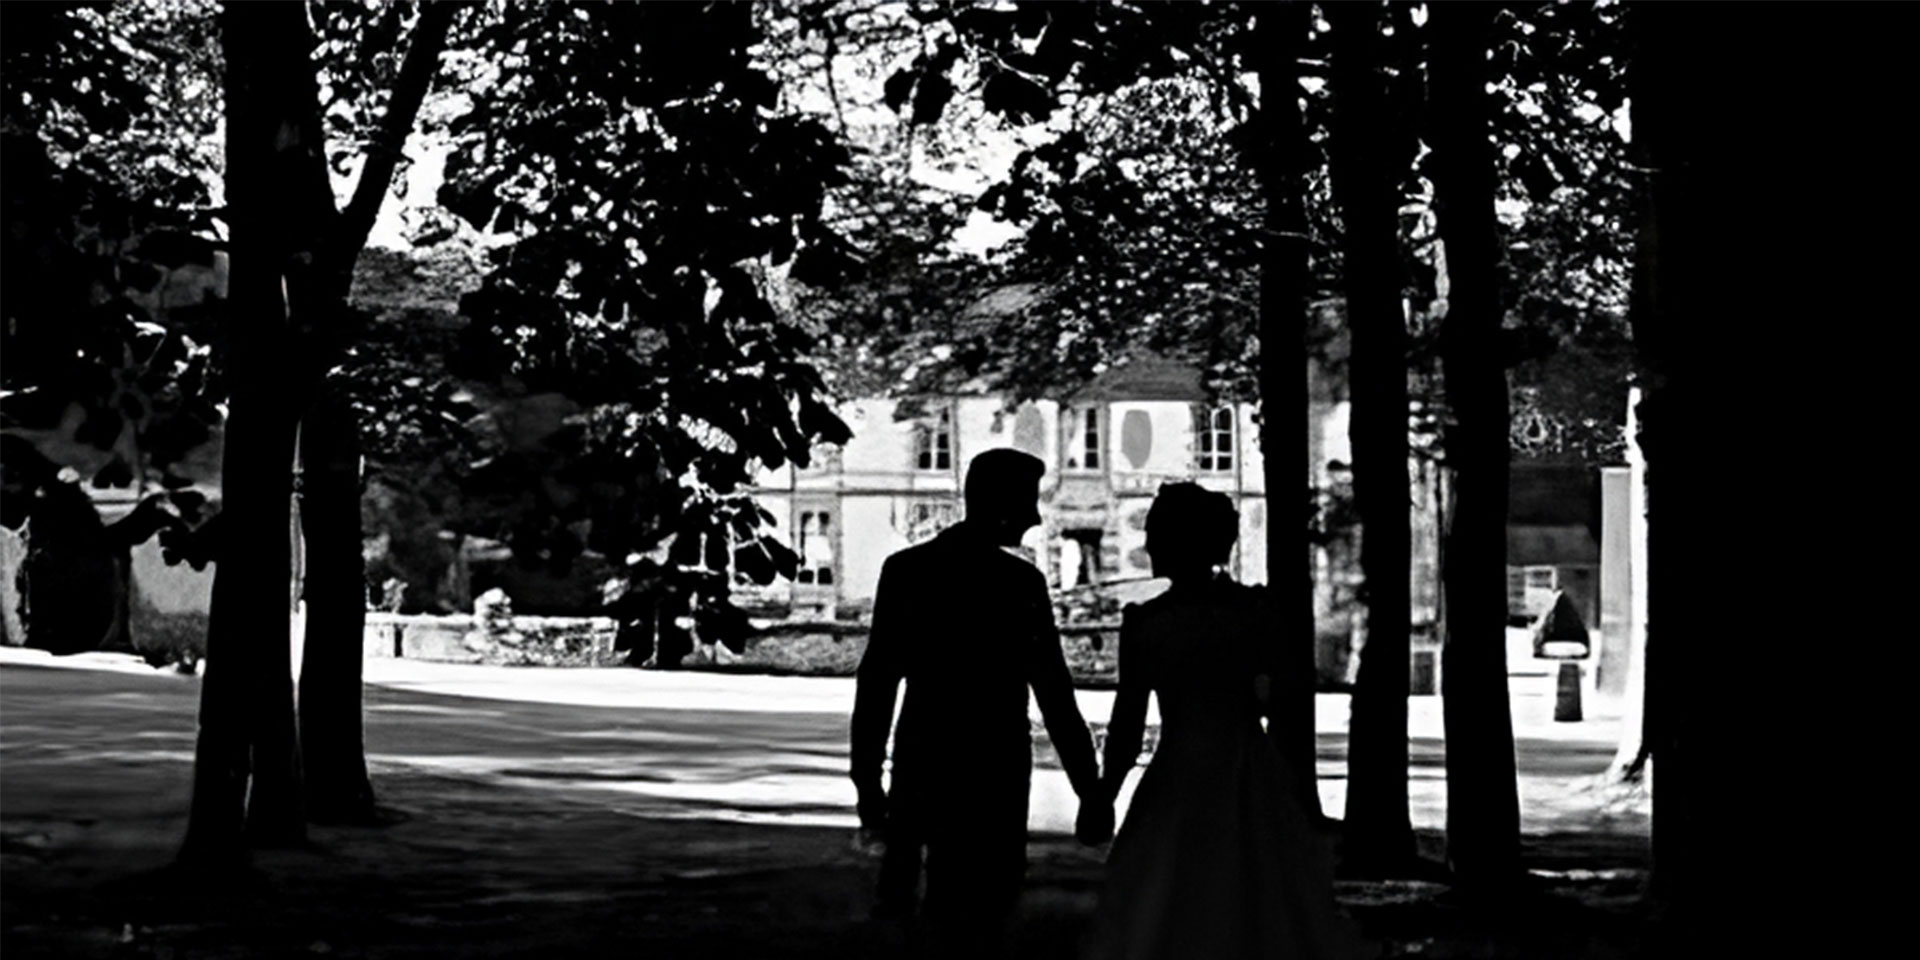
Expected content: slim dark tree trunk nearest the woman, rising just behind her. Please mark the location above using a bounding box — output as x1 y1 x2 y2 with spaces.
1254 2 1321 814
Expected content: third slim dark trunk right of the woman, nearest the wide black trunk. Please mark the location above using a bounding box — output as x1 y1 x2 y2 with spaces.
1428 4 1521 887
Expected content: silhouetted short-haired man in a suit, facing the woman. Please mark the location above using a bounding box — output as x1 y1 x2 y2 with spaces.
852 449 1098 948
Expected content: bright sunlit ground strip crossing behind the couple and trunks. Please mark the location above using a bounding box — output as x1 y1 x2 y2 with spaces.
0 649 1645 835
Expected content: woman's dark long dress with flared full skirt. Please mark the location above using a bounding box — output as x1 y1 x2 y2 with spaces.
1087 580 1367 960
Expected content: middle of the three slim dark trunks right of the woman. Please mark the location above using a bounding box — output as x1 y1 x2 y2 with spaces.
1325 4 1413 874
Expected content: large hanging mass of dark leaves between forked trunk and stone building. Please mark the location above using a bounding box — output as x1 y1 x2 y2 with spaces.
428 4 849 643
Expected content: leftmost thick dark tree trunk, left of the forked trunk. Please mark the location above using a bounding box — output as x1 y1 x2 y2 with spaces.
180 4 321 868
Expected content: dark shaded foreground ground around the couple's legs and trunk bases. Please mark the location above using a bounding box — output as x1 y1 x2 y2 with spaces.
0 774 1642 960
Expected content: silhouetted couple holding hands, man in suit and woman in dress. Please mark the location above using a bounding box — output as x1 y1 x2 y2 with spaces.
852 449 1361 960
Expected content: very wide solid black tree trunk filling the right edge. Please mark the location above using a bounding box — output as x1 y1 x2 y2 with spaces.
1628 4 1912 956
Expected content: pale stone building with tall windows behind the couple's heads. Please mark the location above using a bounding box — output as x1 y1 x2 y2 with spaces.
756 359 1267 614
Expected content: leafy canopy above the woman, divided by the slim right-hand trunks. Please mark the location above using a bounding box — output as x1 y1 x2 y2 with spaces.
802 4 1634 472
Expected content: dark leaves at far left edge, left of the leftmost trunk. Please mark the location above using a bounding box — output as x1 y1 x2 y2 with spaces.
0 2 223 563
